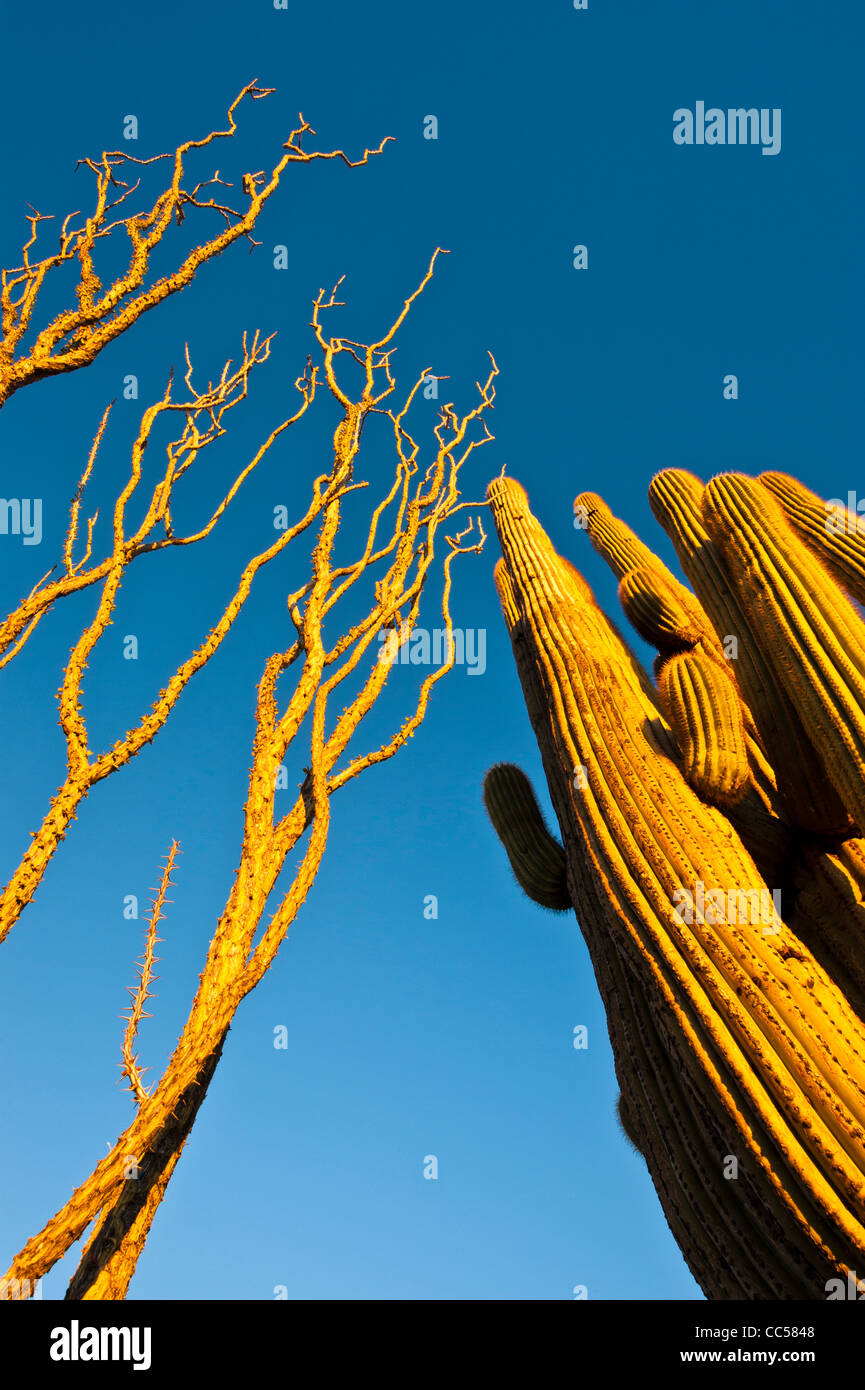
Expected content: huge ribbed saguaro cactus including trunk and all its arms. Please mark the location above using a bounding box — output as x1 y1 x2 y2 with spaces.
485 470 865 1300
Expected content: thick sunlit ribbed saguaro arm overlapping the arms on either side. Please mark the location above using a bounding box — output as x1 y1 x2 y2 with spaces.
704 473 865 830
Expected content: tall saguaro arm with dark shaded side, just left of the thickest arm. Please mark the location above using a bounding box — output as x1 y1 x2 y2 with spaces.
649 468 852 837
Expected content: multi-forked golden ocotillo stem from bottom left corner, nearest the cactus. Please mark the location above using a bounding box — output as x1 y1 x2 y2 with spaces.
3 262 496 1298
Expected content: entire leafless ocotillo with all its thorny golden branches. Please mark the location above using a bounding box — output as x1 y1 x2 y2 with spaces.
0 89 496 1300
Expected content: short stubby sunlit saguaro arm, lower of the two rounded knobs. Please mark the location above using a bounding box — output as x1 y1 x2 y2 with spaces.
658 649 751 806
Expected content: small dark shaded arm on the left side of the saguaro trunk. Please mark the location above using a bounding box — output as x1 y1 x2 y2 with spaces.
484 763 570 912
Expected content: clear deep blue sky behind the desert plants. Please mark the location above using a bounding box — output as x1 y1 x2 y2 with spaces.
0 0 865 1300
